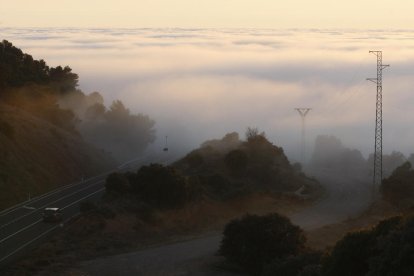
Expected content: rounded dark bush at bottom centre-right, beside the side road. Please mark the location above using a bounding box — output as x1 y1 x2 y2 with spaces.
219 213 305 275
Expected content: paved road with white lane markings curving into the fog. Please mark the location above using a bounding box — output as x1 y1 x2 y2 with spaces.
0 154 174 268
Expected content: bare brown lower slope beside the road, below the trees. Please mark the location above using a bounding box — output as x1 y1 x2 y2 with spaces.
0 104 115 209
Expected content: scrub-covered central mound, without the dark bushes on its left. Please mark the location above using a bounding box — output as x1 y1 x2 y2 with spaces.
173 128 318 199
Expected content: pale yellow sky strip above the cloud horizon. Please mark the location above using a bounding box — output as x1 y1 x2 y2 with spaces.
0 0 414 29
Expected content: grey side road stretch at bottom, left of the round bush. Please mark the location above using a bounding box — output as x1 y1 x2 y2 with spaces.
78 235 238 276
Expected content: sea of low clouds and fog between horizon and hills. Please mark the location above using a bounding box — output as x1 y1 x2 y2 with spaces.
4 28 414 159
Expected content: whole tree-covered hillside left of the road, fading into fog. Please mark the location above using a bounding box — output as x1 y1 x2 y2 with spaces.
0 40 155 209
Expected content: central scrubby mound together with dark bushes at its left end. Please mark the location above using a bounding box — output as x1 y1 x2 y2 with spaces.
98 128 321 229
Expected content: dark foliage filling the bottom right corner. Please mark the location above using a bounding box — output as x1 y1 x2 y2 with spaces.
322 217 414 276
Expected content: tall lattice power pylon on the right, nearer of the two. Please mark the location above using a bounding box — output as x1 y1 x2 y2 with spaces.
367 51 389 199
